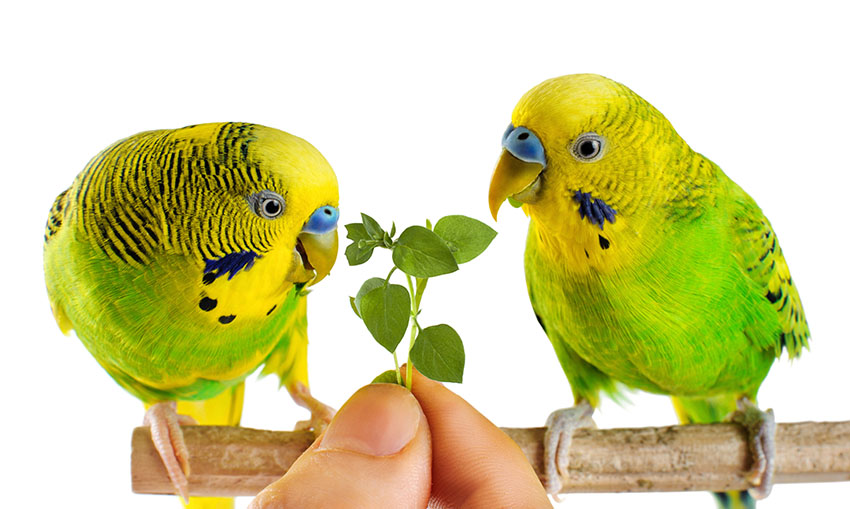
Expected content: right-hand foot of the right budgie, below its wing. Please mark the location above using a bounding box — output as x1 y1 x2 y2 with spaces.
728 398 776 500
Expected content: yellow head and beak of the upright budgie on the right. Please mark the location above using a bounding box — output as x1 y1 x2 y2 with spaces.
489 74 689 222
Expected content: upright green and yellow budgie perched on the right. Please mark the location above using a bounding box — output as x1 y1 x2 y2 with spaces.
489 74 809 507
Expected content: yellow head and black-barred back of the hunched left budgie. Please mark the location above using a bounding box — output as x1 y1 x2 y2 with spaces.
92 122 339 298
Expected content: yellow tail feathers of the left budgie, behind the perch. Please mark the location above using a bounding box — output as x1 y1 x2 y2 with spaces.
177 382 245 509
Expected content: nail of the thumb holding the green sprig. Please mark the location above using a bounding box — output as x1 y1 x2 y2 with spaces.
318 384 421 456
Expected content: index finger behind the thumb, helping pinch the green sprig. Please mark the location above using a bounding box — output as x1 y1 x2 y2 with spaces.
406 370 552 508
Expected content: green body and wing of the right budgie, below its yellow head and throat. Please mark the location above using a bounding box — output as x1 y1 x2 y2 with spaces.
526 159 808 401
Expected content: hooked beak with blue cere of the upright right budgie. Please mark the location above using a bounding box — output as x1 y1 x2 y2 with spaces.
489 125 546 219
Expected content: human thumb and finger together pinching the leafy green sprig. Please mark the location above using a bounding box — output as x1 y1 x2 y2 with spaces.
250 371 551 509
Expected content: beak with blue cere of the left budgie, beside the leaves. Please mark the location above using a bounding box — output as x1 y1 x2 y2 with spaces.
289 205 339 286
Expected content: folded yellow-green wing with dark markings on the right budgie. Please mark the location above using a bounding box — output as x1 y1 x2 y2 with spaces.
732 184 809 358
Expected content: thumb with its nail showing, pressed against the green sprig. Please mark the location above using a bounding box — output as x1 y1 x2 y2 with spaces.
249 384 431 509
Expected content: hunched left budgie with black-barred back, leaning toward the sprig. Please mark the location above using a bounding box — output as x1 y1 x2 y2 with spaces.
44 123 339 507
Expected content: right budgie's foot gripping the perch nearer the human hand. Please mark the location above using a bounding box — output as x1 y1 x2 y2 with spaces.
543 401 596 494
